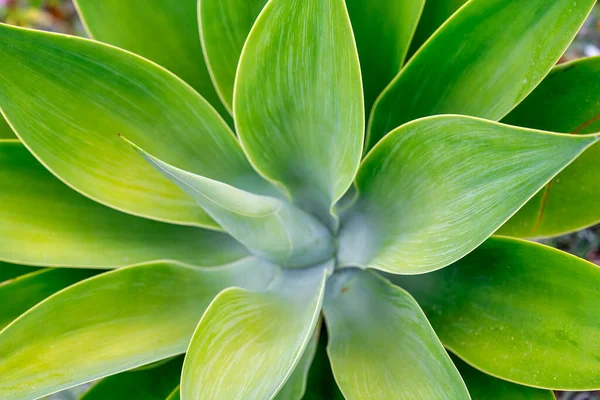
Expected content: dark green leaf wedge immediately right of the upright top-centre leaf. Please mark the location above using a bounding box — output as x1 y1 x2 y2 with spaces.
346 0 425 114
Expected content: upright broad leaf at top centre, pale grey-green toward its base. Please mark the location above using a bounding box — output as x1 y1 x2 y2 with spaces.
234 0 364 220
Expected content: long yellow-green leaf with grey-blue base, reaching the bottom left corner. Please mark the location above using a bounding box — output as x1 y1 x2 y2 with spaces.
0 258 277 400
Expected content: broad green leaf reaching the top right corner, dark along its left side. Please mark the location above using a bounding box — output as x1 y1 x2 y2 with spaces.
367 0 596 147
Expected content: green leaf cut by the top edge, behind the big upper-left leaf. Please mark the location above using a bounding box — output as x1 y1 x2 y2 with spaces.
75 0 232 123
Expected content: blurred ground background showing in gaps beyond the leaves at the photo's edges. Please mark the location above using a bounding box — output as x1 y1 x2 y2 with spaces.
0 0 600 400
